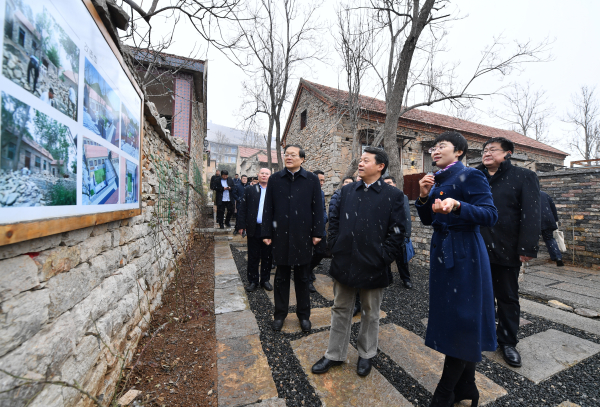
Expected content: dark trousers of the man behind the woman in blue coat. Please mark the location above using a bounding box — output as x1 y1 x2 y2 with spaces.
491 264 521 346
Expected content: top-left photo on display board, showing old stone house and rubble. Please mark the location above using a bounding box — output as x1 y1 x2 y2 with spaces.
2 0 79 121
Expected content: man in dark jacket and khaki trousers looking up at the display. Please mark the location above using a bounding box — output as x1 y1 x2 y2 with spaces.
312 147 406 376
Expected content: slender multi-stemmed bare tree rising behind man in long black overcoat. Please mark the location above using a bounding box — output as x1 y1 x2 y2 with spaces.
231 0 321 169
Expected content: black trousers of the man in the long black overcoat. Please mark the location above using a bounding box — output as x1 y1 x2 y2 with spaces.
273 263 310 321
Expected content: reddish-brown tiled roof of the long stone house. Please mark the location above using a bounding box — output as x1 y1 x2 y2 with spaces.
302 79 569 156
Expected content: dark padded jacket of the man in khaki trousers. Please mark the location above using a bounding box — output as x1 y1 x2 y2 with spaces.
327 178 406 289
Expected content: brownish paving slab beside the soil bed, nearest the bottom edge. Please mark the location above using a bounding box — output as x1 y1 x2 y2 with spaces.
217 334 277 407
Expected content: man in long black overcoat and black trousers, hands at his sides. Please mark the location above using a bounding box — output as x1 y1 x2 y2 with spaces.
262 145 325 332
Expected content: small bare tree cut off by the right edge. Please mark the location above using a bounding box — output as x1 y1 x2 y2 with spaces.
564 86 600 160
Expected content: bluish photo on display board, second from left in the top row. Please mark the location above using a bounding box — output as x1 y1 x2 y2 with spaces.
83 58 121 147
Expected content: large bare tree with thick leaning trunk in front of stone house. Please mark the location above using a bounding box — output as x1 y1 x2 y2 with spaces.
346 0 549 187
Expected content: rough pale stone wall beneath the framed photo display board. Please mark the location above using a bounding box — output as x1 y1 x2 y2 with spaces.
0 109 199 406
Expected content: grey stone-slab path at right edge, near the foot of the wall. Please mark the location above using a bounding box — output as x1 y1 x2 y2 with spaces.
520 262 600 312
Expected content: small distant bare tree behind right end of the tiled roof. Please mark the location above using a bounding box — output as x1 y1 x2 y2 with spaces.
491 82 553 143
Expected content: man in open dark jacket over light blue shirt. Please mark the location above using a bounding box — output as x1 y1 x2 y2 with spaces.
235 168 273 292
